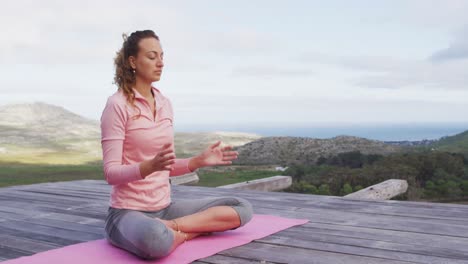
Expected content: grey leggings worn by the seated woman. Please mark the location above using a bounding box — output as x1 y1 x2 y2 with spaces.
106 197 252 259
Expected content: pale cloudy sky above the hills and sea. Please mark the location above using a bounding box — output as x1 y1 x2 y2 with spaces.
0 0 468 133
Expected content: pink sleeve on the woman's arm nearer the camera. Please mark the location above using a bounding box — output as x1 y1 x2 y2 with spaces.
101 99 142 185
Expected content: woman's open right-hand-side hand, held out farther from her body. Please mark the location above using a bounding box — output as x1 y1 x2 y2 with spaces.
197 141 239 167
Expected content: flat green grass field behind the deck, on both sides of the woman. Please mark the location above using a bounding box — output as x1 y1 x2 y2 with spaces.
0 162 279 187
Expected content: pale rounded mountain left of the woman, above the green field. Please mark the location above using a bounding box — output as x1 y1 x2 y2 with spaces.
0 103 101 164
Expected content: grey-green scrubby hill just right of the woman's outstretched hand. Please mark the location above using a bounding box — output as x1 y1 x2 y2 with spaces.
235 136 403 165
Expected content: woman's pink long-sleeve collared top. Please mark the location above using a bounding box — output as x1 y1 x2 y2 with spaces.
101 87 191 211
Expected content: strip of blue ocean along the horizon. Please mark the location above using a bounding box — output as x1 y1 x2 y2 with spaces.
176 123 468 141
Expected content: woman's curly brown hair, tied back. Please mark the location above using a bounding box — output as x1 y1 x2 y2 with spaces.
114 30 159 118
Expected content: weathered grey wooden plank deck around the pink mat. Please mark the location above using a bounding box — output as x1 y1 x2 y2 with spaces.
0 180 468 264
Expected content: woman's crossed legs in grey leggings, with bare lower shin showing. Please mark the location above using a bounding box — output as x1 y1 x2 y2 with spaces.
106 197 252 259
